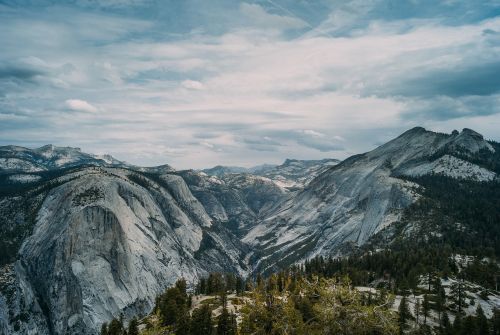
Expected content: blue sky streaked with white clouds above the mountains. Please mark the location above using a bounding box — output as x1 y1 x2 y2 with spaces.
0 0 500 169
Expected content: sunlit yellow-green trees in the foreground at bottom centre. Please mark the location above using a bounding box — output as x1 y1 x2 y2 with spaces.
101 268 399 335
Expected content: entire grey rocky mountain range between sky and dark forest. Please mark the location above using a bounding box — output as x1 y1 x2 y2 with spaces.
0 127 500 334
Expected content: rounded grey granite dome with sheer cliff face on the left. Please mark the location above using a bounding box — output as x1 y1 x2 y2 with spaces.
3 168 248 334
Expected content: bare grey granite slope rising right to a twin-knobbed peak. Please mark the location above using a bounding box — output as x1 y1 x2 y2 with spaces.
243 127 497 271
